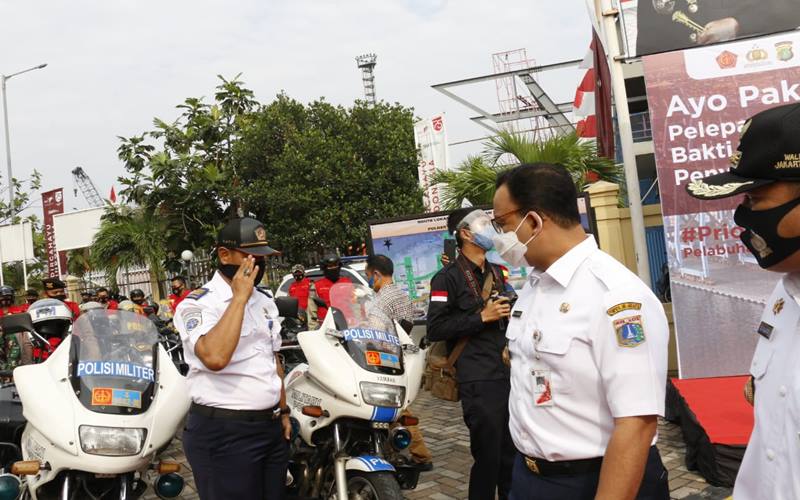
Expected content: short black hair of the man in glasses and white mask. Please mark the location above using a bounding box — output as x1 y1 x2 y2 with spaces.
495 163 581 229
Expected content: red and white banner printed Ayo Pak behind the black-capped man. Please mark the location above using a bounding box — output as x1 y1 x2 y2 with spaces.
643 32 800 378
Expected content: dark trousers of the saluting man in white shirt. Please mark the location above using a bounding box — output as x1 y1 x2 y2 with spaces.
183 413 289 500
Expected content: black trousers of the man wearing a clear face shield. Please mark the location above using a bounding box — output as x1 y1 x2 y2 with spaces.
458 380 516 500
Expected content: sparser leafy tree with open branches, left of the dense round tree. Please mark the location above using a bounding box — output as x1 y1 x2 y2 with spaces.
117 76 258 270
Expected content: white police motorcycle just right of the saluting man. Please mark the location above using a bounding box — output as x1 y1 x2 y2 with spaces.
286 283 425 500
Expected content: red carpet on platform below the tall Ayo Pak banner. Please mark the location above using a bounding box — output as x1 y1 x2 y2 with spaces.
672 376 753 446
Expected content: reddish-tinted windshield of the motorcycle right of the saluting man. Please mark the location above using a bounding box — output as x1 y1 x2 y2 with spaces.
330 283 404 375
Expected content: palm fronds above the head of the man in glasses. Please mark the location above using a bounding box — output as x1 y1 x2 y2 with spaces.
433 131 624 209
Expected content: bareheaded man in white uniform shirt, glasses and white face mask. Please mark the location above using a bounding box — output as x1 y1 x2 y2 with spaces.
493 164 669 500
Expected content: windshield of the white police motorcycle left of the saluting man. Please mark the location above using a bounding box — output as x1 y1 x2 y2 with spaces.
70 309 158 415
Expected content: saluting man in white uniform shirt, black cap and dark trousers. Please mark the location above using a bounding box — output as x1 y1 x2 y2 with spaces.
174 218 291 500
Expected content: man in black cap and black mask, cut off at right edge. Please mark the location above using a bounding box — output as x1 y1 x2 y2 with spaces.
687 104 800 500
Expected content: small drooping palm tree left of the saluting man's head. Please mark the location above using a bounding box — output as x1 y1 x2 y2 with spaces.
91 206 168 300
